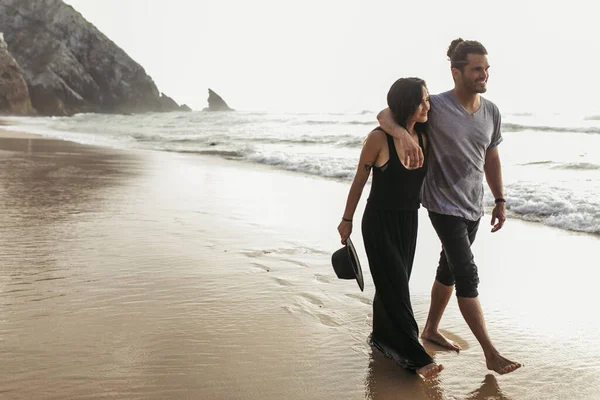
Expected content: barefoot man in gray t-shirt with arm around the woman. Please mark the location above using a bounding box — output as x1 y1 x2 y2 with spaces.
377 39 521 374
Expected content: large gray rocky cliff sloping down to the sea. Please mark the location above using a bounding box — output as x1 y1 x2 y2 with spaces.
0 0 188 115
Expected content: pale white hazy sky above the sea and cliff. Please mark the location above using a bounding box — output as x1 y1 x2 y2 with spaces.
66 0 600 115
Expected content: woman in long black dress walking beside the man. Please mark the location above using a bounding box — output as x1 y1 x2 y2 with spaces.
338 78 443 378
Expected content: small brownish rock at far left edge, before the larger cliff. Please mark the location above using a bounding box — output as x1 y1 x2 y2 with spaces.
0 33 35 115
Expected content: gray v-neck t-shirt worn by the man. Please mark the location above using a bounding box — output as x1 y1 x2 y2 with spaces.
421 91 502 221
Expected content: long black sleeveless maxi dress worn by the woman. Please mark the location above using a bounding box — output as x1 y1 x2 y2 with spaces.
362 128 433 370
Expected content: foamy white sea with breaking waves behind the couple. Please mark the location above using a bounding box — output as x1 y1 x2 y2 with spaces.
8 112 600 234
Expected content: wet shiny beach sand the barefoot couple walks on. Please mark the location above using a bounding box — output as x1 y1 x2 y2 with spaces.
0 133 600 400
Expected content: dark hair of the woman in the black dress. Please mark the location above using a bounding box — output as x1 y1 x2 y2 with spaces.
387 78 427 129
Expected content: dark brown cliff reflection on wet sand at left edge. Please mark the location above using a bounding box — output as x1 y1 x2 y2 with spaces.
0 138 133 222
